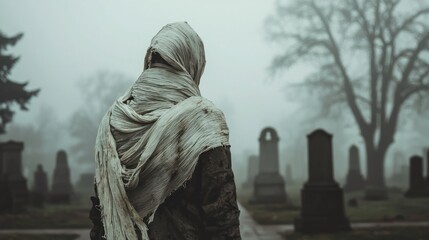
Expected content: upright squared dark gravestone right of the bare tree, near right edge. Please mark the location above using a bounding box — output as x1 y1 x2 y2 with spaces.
405 156 429 198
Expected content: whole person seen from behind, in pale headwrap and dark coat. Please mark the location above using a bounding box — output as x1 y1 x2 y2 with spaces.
90 22 240 240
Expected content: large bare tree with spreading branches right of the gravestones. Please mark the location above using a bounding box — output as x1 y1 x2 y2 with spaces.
266 0 429 199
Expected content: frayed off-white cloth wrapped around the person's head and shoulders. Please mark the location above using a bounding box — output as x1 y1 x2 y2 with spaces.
95 22 229 240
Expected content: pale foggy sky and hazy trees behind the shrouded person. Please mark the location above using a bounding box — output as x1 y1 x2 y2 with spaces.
0 0 429 186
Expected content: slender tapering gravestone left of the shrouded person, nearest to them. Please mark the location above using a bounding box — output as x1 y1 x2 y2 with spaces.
50 150 73 204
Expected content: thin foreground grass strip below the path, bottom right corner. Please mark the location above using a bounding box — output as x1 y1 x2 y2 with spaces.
283 227 429 240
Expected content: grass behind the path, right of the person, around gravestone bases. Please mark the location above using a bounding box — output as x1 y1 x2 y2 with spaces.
238 185 429 224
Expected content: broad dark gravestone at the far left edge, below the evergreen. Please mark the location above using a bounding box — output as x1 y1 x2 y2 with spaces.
0 141 29 210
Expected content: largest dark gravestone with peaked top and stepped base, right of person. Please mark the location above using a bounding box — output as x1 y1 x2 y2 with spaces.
294 129 350 233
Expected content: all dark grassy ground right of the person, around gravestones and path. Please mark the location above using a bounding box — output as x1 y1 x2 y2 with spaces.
237 184 429 240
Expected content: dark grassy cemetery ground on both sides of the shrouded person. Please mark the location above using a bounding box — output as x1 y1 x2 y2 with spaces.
0 184 429 240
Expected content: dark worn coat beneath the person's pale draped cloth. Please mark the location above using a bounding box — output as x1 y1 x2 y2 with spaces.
90 147 241 240
